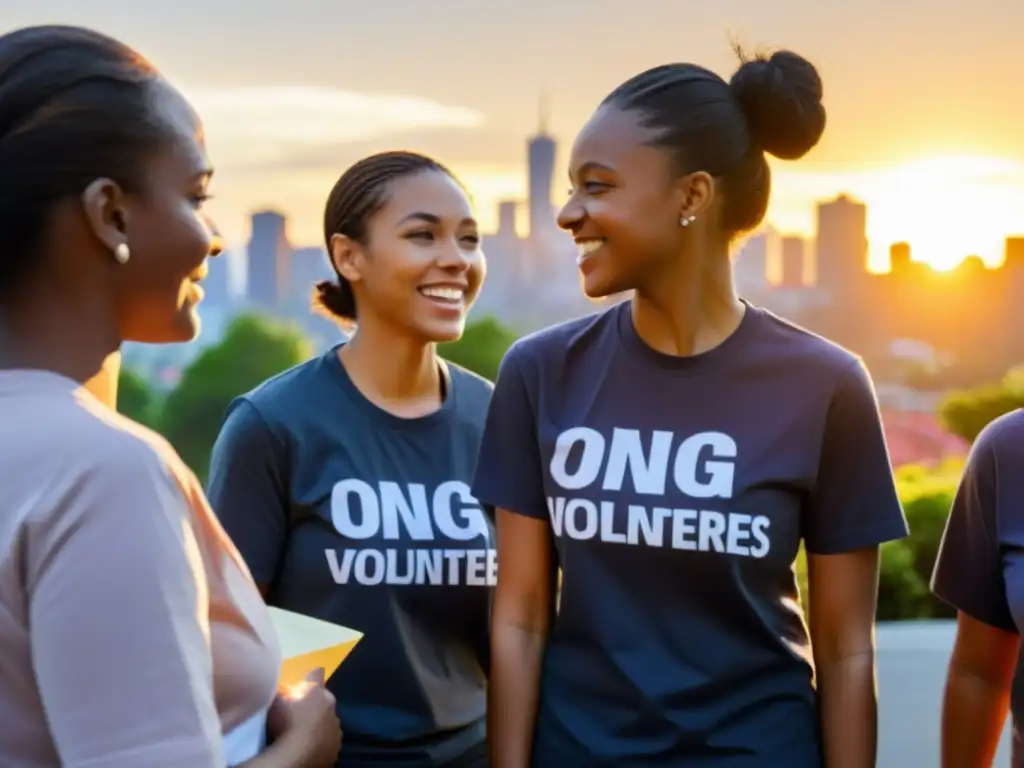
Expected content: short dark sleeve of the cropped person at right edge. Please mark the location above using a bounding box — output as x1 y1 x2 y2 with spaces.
932 423 1017 632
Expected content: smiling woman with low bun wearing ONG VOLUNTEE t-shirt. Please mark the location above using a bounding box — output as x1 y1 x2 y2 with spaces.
209 152 497 768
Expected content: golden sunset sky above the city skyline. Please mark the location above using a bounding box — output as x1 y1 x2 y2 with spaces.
12 0 1024 268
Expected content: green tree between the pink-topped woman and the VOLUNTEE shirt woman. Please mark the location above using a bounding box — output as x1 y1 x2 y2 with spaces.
161 314 311 482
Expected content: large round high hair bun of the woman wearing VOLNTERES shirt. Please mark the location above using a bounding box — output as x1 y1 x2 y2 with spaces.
729 50 825 160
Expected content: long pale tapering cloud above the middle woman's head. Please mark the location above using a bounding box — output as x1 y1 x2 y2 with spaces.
182 86 484 165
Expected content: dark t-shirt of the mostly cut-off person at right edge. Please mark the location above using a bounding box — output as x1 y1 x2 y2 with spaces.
932 411 1024 768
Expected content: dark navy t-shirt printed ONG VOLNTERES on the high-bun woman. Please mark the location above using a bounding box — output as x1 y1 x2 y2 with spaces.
473 302 907 768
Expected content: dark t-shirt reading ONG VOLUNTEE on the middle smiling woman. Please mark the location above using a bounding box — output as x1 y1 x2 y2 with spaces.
209 348 497 768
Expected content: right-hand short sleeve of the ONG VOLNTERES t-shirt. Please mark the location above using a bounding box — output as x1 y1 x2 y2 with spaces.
804 358 907 555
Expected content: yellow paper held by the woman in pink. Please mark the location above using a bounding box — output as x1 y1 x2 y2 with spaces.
268 606 362 690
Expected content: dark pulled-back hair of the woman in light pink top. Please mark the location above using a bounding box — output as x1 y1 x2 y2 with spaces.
0 26 170 298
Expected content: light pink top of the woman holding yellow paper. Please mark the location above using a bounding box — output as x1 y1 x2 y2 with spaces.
0 371 281 768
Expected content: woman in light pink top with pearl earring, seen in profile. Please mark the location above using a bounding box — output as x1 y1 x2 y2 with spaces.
0 27 340 768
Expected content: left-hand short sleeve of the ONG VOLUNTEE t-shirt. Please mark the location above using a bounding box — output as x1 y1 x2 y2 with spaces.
207 398 290 585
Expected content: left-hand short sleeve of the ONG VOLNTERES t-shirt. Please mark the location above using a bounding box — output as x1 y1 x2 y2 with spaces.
473 342 548 520
